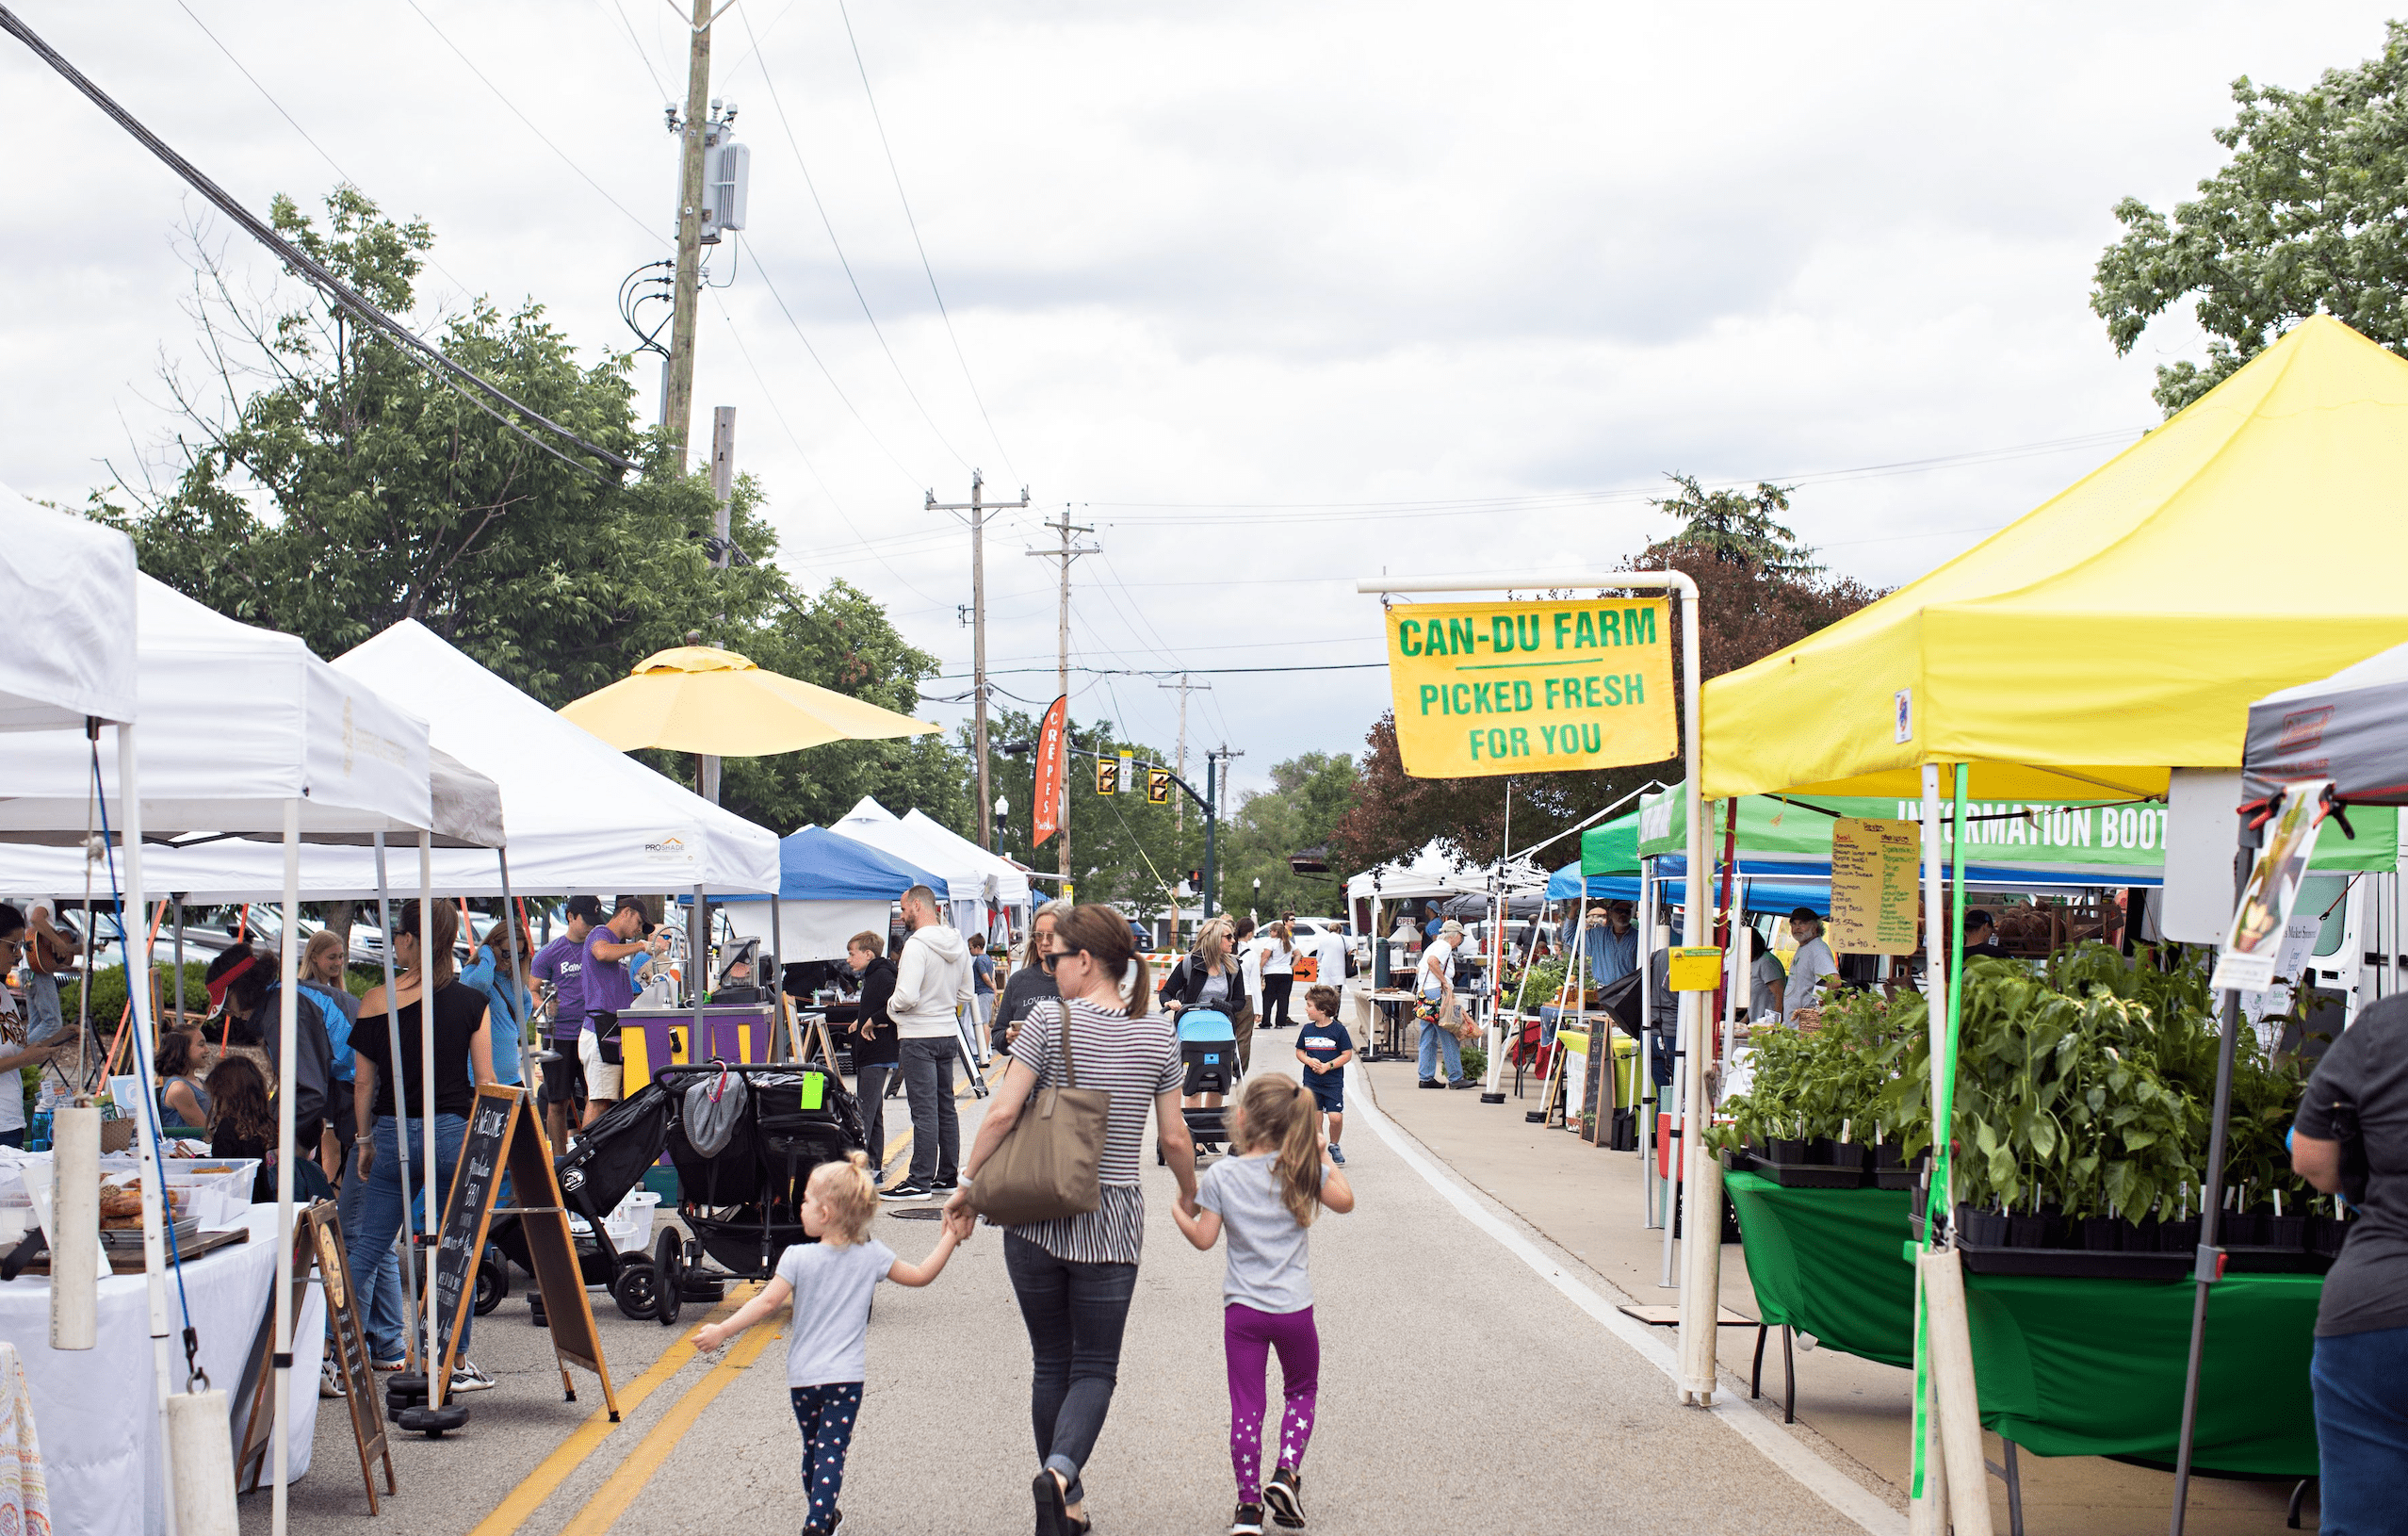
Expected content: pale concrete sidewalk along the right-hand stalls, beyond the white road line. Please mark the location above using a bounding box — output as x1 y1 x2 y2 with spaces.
1346 1062 2317 1536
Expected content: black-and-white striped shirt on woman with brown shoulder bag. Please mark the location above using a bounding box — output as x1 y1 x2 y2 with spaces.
1012 999 1187 1264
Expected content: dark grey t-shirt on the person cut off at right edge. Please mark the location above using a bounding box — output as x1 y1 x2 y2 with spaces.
2295 994 2408 1339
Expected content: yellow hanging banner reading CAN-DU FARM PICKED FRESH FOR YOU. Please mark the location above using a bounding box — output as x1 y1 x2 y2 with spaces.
1387 597 1681 777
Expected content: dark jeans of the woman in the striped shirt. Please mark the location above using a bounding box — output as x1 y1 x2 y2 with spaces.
1006 1233 1136 1505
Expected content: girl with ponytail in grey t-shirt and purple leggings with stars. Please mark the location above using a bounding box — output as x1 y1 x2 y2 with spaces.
1173 1073 1353 1536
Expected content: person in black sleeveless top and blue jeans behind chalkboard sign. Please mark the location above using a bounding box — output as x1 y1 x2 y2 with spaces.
350 898 494 1394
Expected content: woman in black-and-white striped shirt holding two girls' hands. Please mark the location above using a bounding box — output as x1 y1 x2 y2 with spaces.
944 903 1196 1536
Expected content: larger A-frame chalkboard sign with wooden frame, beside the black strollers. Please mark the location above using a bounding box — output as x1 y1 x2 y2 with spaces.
426 1084 619 1423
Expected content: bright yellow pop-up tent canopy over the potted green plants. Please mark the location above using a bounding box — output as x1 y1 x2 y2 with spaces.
1700 316 2408 799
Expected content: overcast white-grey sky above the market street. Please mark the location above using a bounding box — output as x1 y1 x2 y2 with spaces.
0 0 2384 814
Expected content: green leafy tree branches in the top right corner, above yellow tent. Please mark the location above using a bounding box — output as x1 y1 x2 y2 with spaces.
2091 22 2408 414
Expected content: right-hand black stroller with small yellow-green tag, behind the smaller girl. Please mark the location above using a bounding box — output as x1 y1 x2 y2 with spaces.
653 1062 865 1322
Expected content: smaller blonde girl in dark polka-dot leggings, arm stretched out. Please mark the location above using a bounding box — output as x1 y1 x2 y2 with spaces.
693 1153 961 1536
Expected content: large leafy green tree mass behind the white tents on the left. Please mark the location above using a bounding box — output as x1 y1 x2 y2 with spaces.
94 188 968 833
